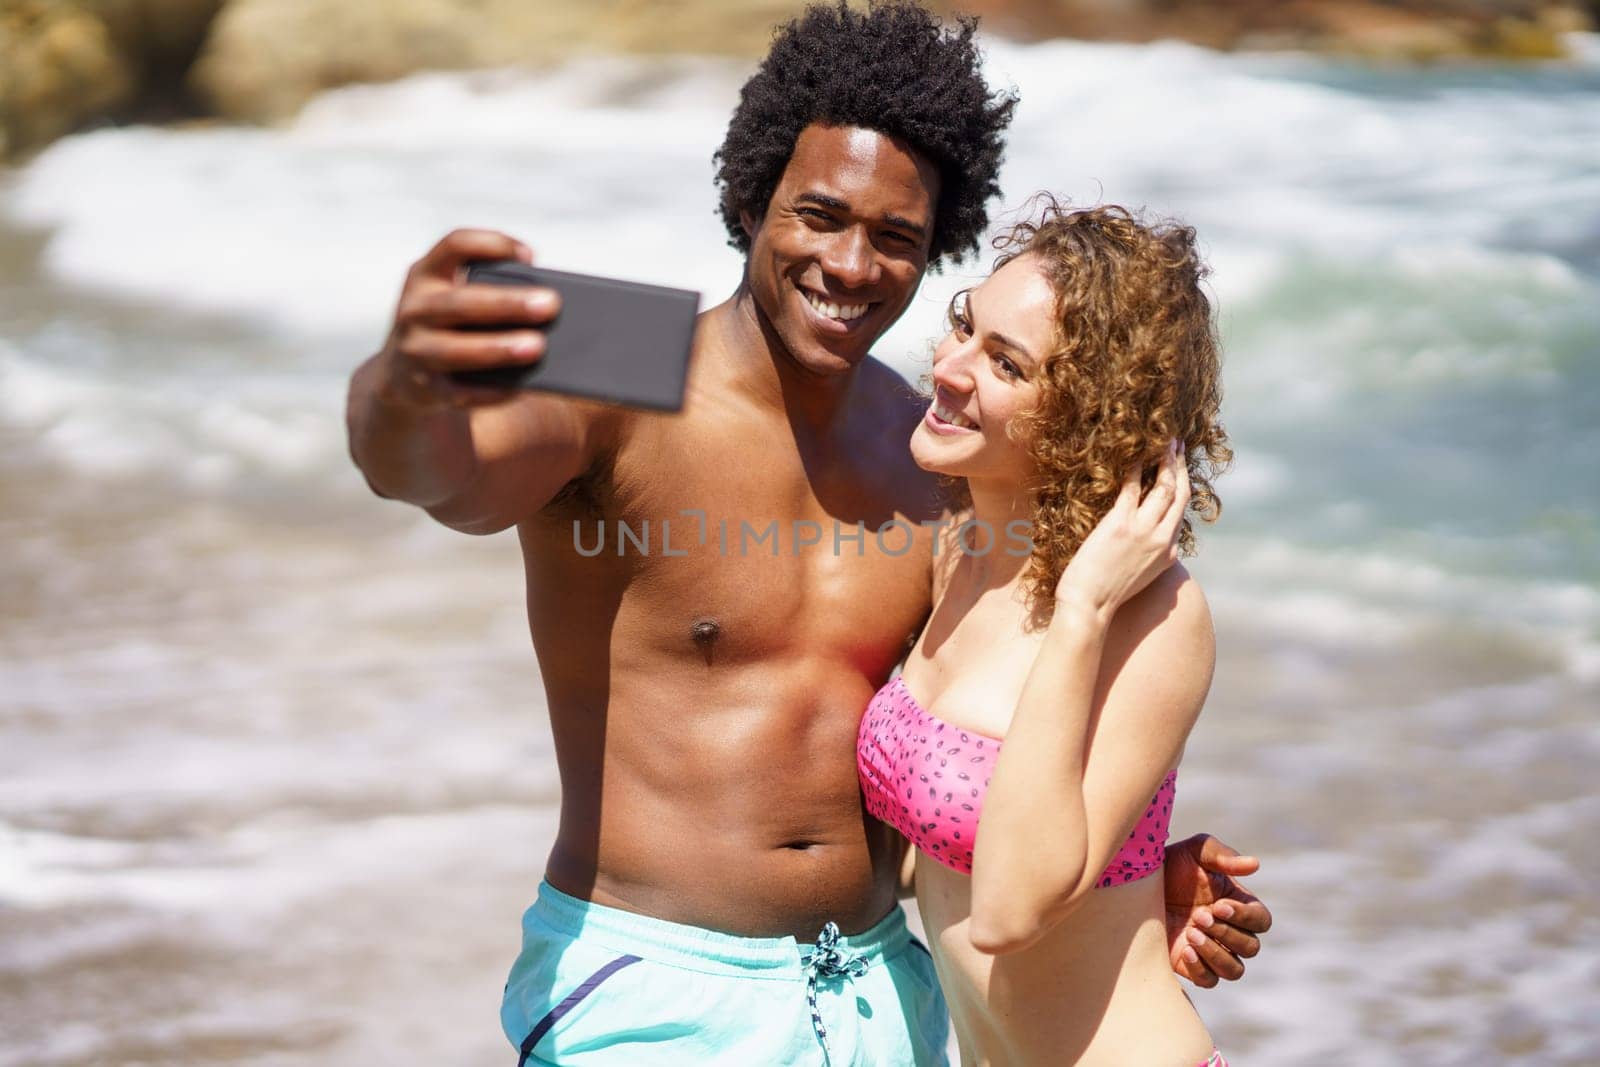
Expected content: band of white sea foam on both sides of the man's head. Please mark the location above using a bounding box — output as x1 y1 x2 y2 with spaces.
10 42 1600 340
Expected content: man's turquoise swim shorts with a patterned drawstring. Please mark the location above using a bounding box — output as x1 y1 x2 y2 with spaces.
501 883 950 1067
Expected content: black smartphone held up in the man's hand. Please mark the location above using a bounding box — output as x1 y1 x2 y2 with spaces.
453 259 699 411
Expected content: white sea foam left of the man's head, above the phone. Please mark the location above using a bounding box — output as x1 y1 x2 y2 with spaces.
10 61 738 339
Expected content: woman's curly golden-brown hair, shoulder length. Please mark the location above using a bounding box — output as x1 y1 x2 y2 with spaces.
994 194 1234 621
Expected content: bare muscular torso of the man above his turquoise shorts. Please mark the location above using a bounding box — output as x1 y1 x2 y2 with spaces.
518 302 939 939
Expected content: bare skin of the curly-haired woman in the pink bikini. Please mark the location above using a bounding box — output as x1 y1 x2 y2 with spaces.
904 256 1213 1067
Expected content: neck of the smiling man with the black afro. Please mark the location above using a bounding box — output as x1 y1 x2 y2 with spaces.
709 285 856 432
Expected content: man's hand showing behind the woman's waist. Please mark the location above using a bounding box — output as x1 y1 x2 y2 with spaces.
1162 833 1272 989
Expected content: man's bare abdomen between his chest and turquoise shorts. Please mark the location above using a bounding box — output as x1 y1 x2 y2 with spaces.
547 661 898 939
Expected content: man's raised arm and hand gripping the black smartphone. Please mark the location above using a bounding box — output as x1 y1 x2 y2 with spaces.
346 230 606 533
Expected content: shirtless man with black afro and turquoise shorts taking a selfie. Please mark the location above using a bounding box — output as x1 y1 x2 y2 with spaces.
349 3 1267 1067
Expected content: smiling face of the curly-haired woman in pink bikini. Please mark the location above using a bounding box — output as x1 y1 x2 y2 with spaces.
910 254 1056 483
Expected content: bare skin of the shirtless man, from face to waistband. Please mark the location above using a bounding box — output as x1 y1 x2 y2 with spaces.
349 119 1254 973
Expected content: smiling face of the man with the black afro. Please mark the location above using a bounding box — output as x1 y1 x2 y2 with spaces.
744 126 939 374
